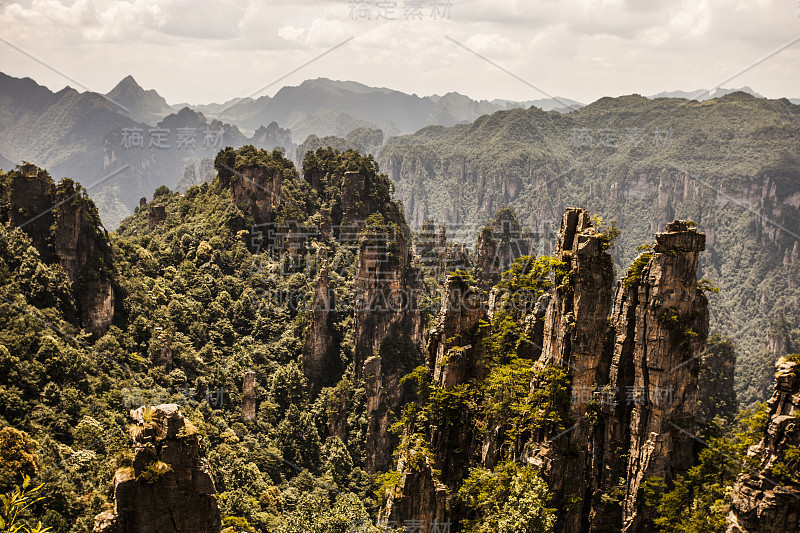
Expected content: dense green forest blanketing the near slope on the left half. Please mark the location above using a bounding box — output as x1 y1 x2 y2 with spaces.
0 147 402 532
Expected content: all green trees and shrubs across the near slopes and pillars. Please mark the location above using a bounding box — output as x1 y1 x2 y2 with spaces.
0 140 800 533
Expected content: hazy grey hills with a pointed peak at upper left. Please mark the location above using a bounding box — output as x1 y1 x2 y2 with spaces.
0 73 295 229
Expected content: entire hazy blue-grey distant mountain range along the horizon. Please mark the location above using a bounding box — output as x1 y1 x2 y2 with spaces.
0 73 800 229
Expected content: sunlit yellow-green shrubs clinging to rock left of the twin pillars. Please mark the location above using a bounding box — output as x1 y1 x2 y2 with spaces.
379 256 569 533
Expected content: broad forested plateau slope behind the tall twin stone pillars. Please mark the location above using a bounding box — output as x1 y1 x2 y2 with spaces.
378 92 800 403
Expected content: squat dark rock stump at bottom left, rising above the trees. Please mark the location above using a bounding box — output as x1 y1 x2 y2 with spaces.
94 404 221 533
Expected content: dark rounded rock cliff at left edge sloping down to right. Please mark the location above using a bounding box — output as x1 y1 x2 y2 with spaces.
0 165 114 336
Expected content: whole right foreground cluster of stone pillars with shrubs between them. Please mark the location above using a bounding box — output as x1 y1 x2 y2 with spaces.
381 208 708 533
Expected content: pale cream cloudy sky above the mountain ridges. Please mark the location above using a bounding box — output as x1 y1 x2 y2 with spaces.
0 0 800 104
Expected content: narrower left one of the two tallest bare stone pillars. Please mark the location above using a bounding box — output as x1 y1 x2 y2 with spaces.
529 208 613 533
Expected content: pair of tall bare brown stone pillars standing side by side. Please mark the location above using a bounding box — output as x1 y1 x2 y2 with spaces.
531 214 708 533
